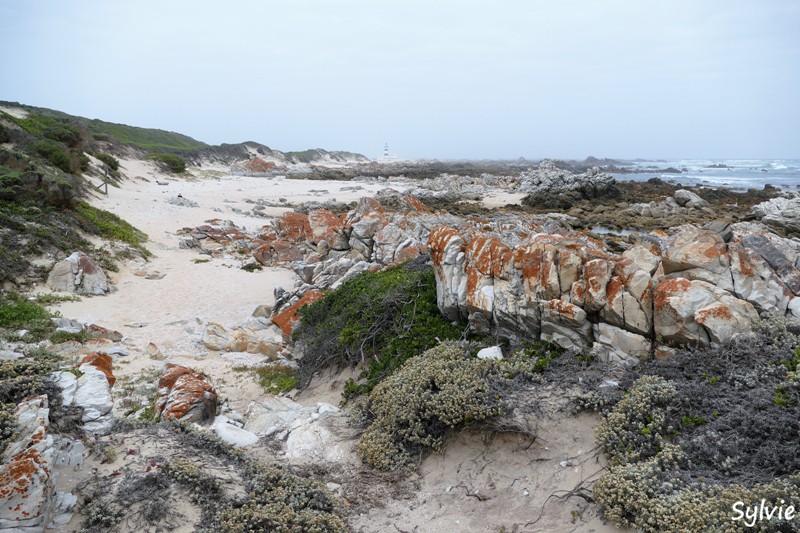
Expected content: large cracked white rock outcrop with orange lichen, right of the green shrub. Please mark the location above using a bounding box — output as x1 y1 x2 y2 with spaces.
428 222 800 361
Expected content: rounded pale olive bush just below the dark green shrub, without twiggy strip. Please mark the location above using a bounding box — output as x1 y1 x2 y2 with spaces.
357 341 504 470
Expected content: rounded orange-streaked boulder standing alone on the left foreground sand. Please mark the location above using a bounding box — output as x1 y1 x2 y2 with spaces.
155 363 217 422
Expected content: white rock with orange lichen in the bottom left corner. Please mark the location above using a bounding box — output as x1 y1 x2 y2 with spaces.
0 396 54 532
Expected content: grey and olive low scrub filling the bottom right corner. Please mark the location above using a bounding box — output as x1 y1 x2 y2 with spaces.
594 319 800 532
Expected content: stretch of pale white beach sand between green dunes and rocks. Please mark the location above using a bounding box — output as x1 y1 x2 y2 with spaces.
57 160 412 354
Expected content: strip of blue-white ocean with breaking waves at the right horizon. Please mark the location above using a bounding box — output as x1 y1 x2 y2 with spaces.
612 159 800 190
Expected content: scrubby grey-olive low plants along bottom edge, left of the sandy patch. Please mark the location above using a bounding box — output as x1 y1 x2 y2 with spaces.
80 421 348 533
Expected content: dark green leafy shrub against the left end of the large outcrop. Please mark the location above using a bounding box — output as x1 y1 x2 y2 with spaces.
293 262 463 394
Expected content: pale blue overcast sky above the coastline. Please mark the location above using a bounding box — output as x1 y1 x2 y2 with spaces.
0 0 800 159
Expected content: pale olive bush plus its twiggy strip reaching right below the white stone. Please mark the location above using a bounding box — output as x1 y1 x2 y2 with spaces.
351 341 576 470
